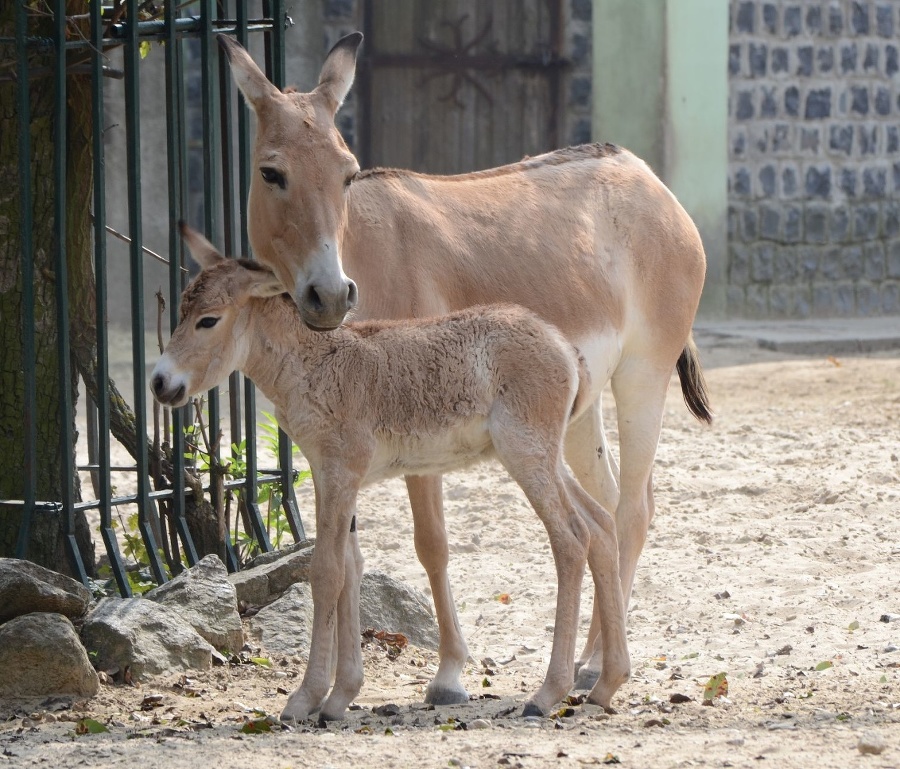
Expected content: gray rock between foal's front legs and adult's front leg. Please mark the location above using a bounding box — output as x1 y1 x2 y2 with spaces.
359 571 439 649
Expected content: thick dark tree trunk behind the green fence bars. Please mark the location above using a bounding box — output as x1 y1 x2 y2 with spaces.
0 0 94 572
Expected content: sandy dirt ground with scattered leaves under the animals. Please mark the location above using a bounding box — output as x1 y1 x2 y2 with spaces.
0 334 900 769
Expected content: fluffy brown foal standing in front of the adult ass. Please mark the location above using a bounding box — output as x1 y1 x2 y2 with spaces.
151 226 630 720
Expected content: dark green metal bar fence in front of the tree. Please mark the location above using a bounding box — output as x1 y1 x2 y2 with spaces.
0 0 305 595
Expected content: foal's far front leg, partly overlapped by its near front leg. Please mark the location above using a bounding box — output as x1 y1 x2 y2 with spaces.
321 515 363 721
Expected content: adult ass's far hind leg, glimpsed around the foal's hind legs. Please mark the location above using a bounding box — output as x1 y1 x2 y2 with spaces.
565 398 619 689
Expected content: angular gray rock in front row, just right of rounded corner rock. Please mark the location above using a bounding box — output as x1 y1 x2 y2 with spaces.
81 598 215 680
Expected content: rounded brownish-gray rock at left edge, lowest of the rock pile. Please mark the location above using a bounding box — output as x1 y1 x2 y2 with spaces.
0 613 100 697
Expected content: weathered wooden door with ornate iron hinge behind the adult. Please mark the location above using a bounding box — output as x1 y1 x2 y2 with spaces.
359 0 567 174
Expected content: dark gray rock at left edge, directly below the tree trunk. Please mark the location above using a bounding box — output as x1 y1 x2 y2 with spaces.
0 558 91 622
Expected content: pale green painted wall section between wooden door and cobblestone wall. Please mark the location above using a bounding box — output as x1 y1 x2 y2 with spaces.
593 0 728 317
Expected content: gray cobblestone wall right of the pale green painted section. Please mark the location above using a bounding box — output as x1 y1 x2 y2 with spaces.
728 0 900 318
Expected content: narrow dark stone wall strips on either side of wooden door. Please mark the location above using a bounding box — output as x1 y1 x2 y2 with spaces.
322 0 593 158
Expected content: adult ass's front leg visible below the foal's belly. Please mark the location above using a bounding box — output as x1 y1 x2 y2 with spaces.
406 475 469 705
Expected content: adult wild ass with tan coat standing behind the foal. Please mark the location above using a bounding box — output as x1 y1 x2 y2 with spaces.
219 33 711 703
